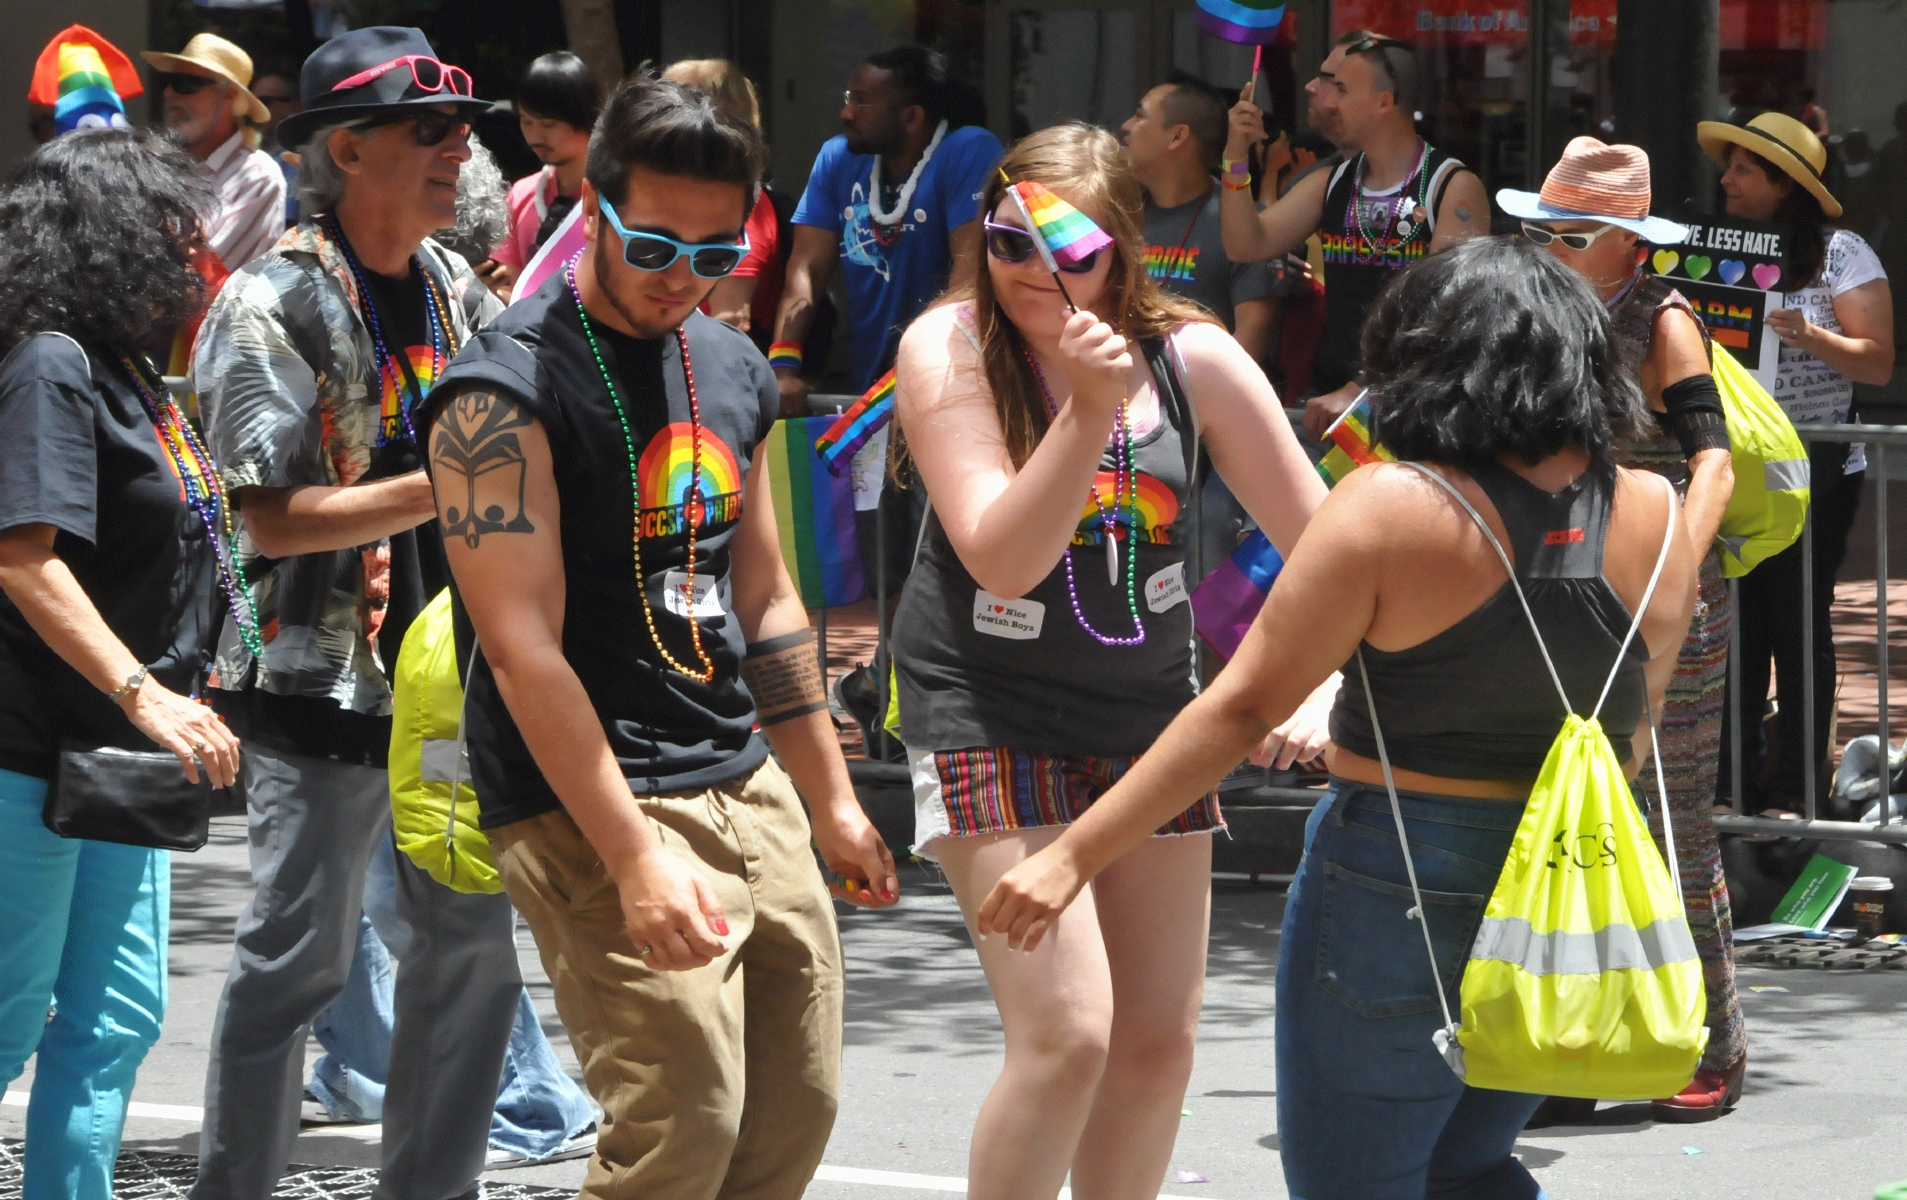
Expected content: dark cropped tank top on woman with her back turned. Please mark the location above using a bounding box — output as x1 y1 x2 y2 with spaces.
1331 464 1648 780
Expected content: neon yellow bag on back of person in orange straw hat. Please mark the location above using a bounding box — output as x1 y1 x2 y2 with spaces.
1709 345 1810 578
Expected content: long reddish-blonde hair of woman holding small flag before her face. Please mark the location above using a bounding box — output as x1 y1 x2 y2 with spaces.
940 120 1217 467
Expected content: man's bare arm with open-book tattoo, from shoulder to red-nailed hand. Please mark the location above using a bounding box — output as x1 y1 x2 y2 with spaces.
429 391 728 971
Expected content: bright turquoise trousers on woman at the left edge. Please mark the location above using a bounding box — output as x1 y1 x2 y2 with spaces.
0 771 172 1200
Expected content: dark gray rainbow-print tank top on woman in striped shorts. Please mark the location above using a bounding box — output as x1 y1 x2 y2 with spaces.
892 328 1198 757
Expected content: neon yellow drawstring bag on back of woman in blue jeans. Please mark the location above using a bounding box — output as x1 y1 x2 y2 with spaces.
1358 464 1709 1101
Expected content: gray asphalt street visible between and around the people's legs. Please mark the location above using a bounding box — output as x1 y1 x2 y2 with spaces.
0 820 1907 1200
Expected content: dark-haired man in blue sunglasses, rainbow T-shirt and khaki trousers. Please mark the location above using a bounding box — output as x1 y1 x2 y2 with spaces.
418 78 898 1200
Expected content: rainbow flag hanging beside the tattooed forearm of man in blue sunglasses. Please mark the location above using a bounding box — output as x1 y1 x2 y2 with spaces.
761 416 868 609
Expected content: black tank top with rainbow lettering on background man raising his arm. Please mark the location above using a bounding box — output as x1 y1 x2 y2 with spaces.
1312 145 1465 395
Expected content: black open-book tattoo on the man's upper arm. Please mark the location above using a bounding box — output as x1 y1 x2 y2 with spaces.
431 391 536 549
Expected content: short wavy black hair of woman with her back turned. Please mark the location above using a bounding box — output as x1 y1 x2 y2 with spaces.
1364 237 1646 473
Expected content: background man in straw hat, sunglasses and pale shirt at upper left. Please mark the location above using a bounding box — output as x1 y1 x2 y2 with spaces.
139 32 286 271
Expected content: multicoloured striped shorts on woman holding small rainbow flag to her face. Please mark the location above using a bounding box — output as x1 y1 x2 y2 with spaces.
908 746 1224 859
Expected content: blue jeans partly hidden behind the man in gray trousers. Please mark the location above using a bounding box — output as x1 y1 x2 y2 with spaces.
305 838 595 1160
